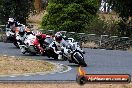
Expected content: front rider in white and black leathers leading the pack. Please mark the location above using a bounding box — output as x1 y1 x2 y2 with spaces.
49 32 68 60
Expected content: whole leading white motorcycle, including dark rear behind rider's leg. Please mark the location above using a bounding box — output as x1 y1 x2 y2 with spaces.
47 38 87 67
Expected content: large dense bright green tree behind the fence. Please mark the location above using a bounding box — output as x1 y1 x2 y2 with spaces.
41 0 98 32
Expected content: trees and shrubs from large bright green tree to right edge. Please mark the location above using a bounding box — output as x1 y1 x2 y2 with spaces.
41 0 132 36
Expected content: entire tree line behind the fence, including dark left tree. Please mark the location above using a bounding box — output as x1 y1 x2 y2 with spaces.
0 0 132 36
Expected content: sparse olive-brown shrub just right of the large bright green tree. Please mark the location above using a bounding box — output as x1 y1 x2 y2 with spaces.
86 17 119 36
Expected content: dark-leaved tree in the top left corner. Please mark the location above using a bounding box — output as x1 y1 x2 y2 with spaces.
0 0 33 23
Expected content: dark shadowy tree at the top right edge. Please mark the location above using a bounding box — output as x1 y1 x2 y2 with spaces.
109 0 132 37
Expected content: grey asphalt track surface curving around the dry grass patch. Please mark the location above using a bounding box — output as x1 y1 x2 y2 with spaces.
0 42 132 81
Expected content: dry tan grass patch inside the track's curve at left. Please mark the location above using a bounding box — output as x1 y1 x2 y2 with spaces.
0 55 56 75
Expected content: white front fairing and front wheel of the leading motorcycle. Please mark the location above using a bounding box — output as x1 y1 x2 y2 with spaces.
63 38 87 67
